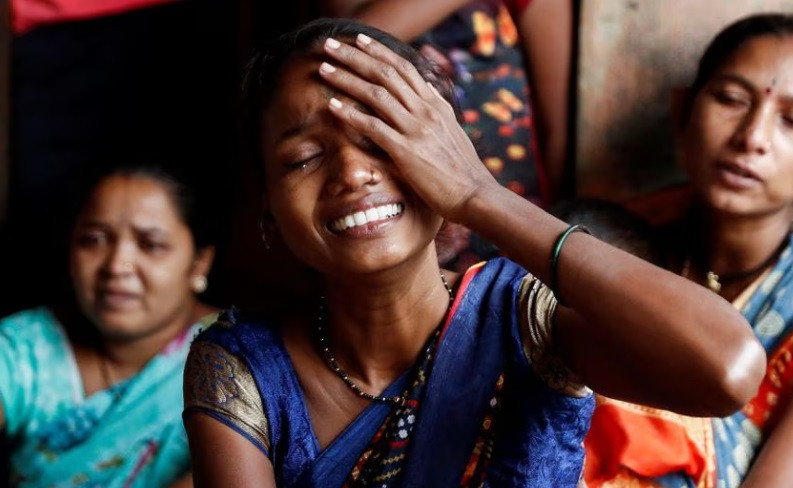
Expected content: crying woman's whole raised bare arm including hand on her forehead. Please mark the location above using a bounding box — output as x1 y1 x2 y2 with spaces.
321 33 765 416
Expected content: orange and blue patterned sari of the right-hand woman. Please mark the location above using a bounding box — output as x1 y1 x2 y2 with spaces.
585 235 793 488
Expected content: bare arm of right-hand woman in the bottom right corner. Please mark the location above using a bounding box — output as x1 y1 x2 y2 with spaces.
741 401 793 488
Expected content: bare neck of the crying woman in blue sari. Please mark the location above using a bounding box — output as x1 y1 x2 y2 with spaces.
325 248 451 391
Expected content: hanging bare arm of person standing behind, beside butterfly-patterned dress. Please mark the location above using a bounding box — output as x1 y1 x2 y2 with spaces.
515 0 573 198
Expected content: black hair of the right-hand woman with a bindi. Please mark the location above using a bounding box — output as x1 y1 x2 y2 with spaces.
683 13 793 121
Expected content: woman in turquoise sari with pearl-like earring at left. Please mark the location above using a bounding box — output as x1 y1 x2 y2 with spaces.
0 165 215 487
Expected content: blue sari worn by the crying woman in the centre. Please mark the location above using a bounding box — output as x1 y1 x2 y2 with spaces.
186 258 593 487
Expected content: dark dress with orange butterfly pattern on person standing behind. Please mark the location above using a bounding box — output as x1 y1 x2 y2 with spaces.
419 0 548 271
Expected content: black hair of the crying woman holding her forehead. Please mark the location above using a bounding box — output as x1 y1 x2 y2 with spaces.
242 18 462 176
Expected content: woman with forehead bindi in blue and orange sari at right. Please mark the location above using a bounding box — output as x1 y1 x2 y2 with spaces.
586 14 793 488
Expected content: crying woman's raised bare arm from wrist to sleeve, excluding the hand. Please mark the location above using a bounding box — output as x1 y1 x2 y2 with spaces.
470 186 765 416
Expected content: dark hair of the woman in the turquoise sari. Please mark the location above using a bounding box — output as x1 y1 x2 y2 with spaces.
70 160 217 251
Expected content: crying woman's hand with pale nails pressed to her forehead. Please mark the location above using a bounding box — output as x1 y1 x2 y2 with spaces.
319 34 498 221
